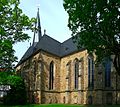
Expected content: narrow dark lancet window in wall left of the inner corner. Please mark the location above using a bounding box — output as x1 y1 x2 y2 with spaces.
49 61 54 90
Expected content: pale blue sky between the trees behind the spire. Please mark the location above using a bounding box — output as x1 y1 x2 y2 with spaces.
14 0 71 61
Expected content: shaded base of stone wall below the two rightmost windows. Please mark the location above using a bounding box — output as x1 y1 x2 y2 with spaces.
86 87 120 105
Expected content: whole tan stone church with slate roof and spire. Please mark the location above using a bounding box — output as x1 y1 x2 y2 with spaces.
16 11 120 104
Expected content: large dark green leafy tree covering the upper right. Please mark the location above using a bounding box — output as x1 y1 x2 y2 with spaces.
63 0 120 75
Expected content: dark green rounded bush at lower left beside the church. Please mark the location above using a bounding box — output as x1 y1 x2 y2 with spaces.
0 72 27 105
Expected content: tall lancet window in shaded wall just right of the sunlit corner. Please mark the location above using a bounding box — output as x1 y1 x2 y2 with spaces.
88 56 94 88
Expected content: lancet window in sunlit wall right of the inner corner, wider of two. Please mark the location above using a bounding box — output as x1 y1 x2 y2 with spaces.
74 59 79 89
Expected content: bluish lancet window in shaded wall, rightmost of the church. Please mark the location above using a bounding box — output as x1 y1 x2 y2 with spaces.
105 58 111 87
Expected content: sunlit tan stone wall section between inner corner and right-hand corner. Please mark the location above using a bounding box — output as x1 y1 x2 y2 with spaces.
60 50 88 104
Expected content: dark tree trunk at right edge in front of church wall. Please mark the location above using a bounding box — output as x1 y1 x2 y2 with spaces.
113 54 120 76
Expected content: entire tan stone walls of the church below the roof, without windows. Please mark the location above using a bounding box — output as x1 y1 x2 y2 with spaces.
16 50 120 104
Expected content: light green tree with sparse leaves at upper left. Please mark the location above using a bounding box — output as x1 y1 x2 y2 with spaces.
0 0 36 71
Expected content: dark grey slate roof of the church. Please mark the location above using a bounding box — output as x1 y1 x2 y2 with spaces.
17 35 83 66
